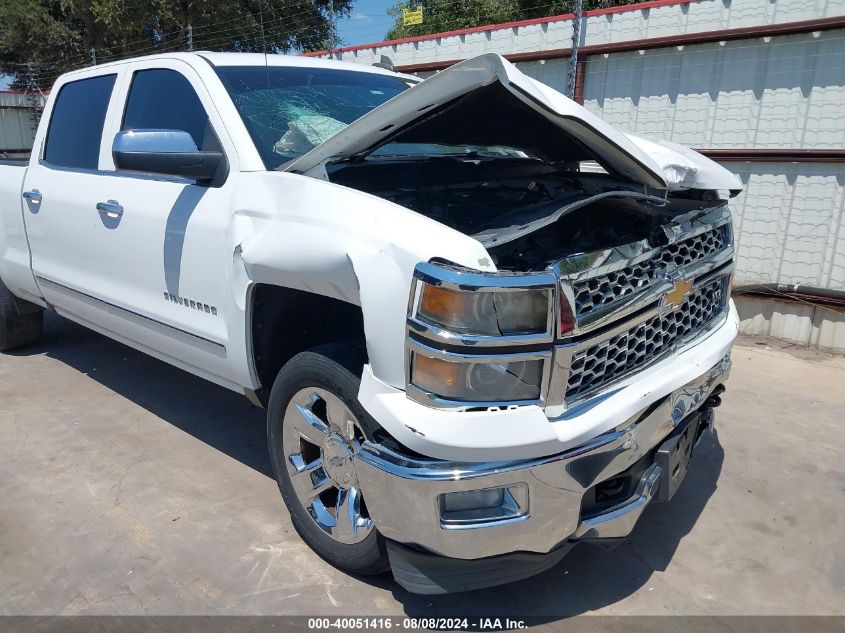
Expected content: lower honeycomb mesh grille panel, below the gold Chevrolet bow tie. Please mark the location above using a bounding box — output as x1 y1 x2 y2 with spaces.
566 276 727 400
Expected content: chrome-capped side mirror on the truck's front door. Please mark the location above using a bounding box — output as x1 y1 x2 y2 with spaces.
112 130 226 182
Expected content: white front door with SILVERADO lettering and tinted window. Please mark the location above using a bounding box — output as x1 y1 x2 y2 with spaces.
49 60 235 386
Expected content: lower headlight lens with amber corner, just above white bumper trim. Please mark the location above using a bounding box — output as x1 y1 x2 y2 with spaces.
411 352 543 403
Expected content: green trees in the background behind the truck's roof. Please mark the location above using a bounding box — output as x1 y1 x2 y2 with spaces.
0 0 353 89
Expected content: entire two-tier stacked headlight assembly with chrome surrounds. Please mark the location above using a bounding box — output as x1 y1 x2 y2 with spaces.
406 263 558 407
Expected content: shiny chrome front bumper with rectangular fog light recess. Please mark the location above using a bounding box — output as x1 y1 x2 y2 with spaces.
356 356 731 559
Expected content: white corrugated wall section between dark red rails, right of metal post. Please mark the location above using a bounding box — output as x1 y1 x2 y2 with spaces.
584 31 845 149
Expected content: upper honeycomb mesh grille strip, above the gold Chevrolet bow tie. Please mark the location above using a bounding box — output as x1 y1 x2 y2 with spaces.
574 225 728 317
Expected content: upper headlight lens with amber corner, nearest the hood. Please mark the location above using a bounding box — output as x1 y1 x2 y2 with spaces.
415 282 552 336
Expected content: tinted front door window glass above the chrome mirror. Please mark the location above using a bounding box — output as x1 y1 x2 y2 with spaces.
121 69 222 152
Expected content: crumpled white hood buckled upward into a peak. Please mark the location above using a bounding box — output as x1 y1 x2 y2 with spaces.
284 53 741 190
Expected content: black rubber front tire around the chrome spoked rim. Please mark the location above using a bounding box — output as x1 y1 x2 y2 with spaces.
267 342 390 575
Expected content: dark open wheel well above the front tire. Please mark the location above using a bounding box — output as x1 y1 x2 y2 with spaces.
249 284 365 406
